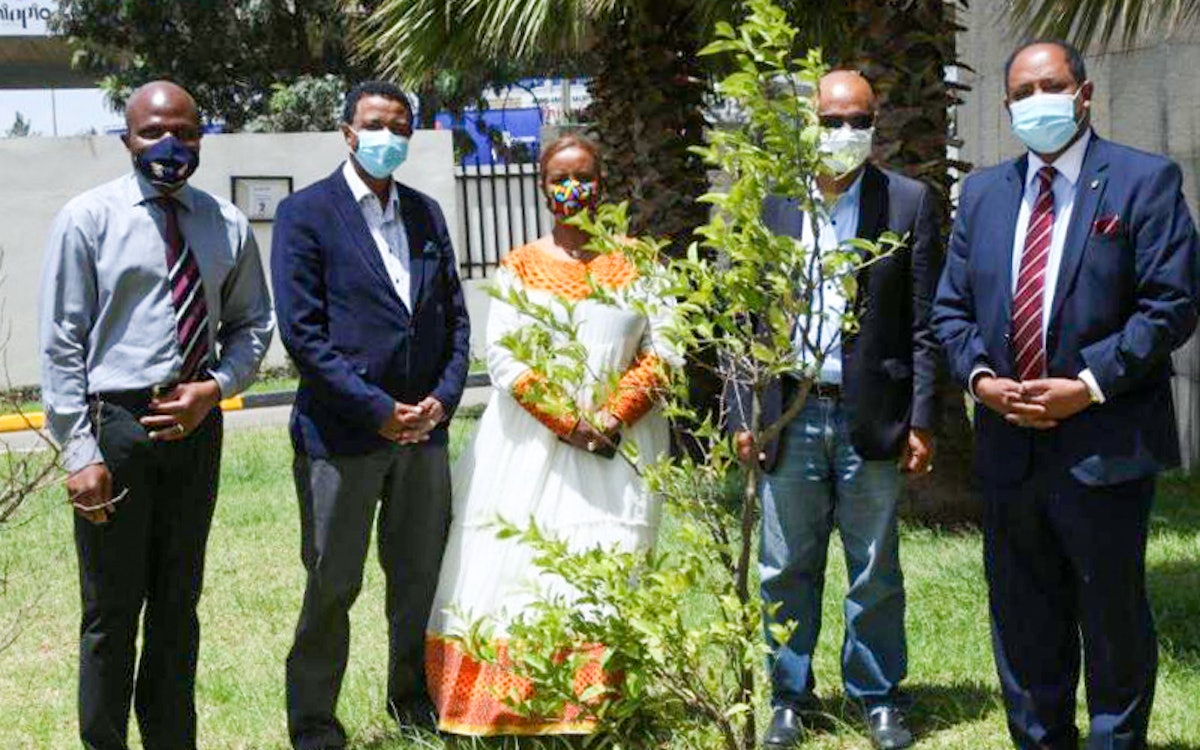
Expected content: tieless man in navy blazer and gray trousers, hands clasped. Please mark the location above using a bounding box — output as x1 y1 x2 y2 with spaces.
271 82 469 750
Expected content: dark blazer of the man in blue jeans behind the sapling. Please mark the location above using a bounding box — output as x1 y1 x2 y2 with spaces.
726 164 942 472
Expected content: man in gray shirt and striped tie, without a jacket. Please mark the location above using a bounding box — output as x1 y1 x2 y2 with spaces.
41 82 274 750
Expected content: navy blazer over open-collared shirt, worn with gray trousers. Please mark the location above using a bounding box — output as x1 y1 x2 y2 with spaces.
271 169 470 457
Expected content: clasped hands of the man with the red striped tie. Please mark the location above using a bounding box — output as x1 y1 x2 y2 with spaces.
974 374 1092 430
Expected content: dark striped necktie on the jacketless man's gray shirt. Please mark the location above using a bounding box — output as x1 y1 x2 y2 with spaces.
158 196 209 382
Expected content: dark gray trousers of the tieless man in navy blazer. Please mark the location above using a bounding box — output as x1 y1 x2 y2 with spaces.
287 443 450 750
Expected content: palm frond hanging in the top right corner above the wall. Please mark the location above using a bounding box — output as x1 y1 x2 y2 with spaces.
1009 0 1200 48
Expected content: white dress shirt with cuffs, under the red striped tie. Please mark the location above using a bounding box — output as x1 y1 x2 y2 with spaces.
971 130 1104 402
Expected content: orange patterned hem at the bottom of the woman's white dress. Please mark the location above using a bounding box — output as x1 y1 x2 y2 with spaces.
425 634 611 737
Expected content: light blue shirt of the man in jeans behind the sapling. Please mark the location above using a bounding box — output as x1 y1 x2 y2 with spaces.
794 173 863 385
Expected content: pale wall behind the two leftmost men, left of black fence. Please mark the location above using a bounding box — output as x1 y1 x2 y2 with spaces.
0 131 458 386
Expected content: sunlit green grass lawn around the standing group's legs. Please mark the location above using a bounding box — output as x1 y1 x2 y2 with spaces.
0 419 1200 750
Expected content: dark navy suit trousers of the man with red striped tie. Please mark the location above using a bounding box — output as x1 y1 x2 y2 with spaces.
984 468 1158 750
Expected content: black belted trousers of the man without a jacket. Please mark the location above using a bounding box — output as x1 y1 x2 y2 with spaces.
74 394 222 750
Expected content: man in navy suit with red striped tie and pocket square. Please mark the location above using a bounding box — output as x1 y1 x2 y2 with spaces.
934 41 1198 750
